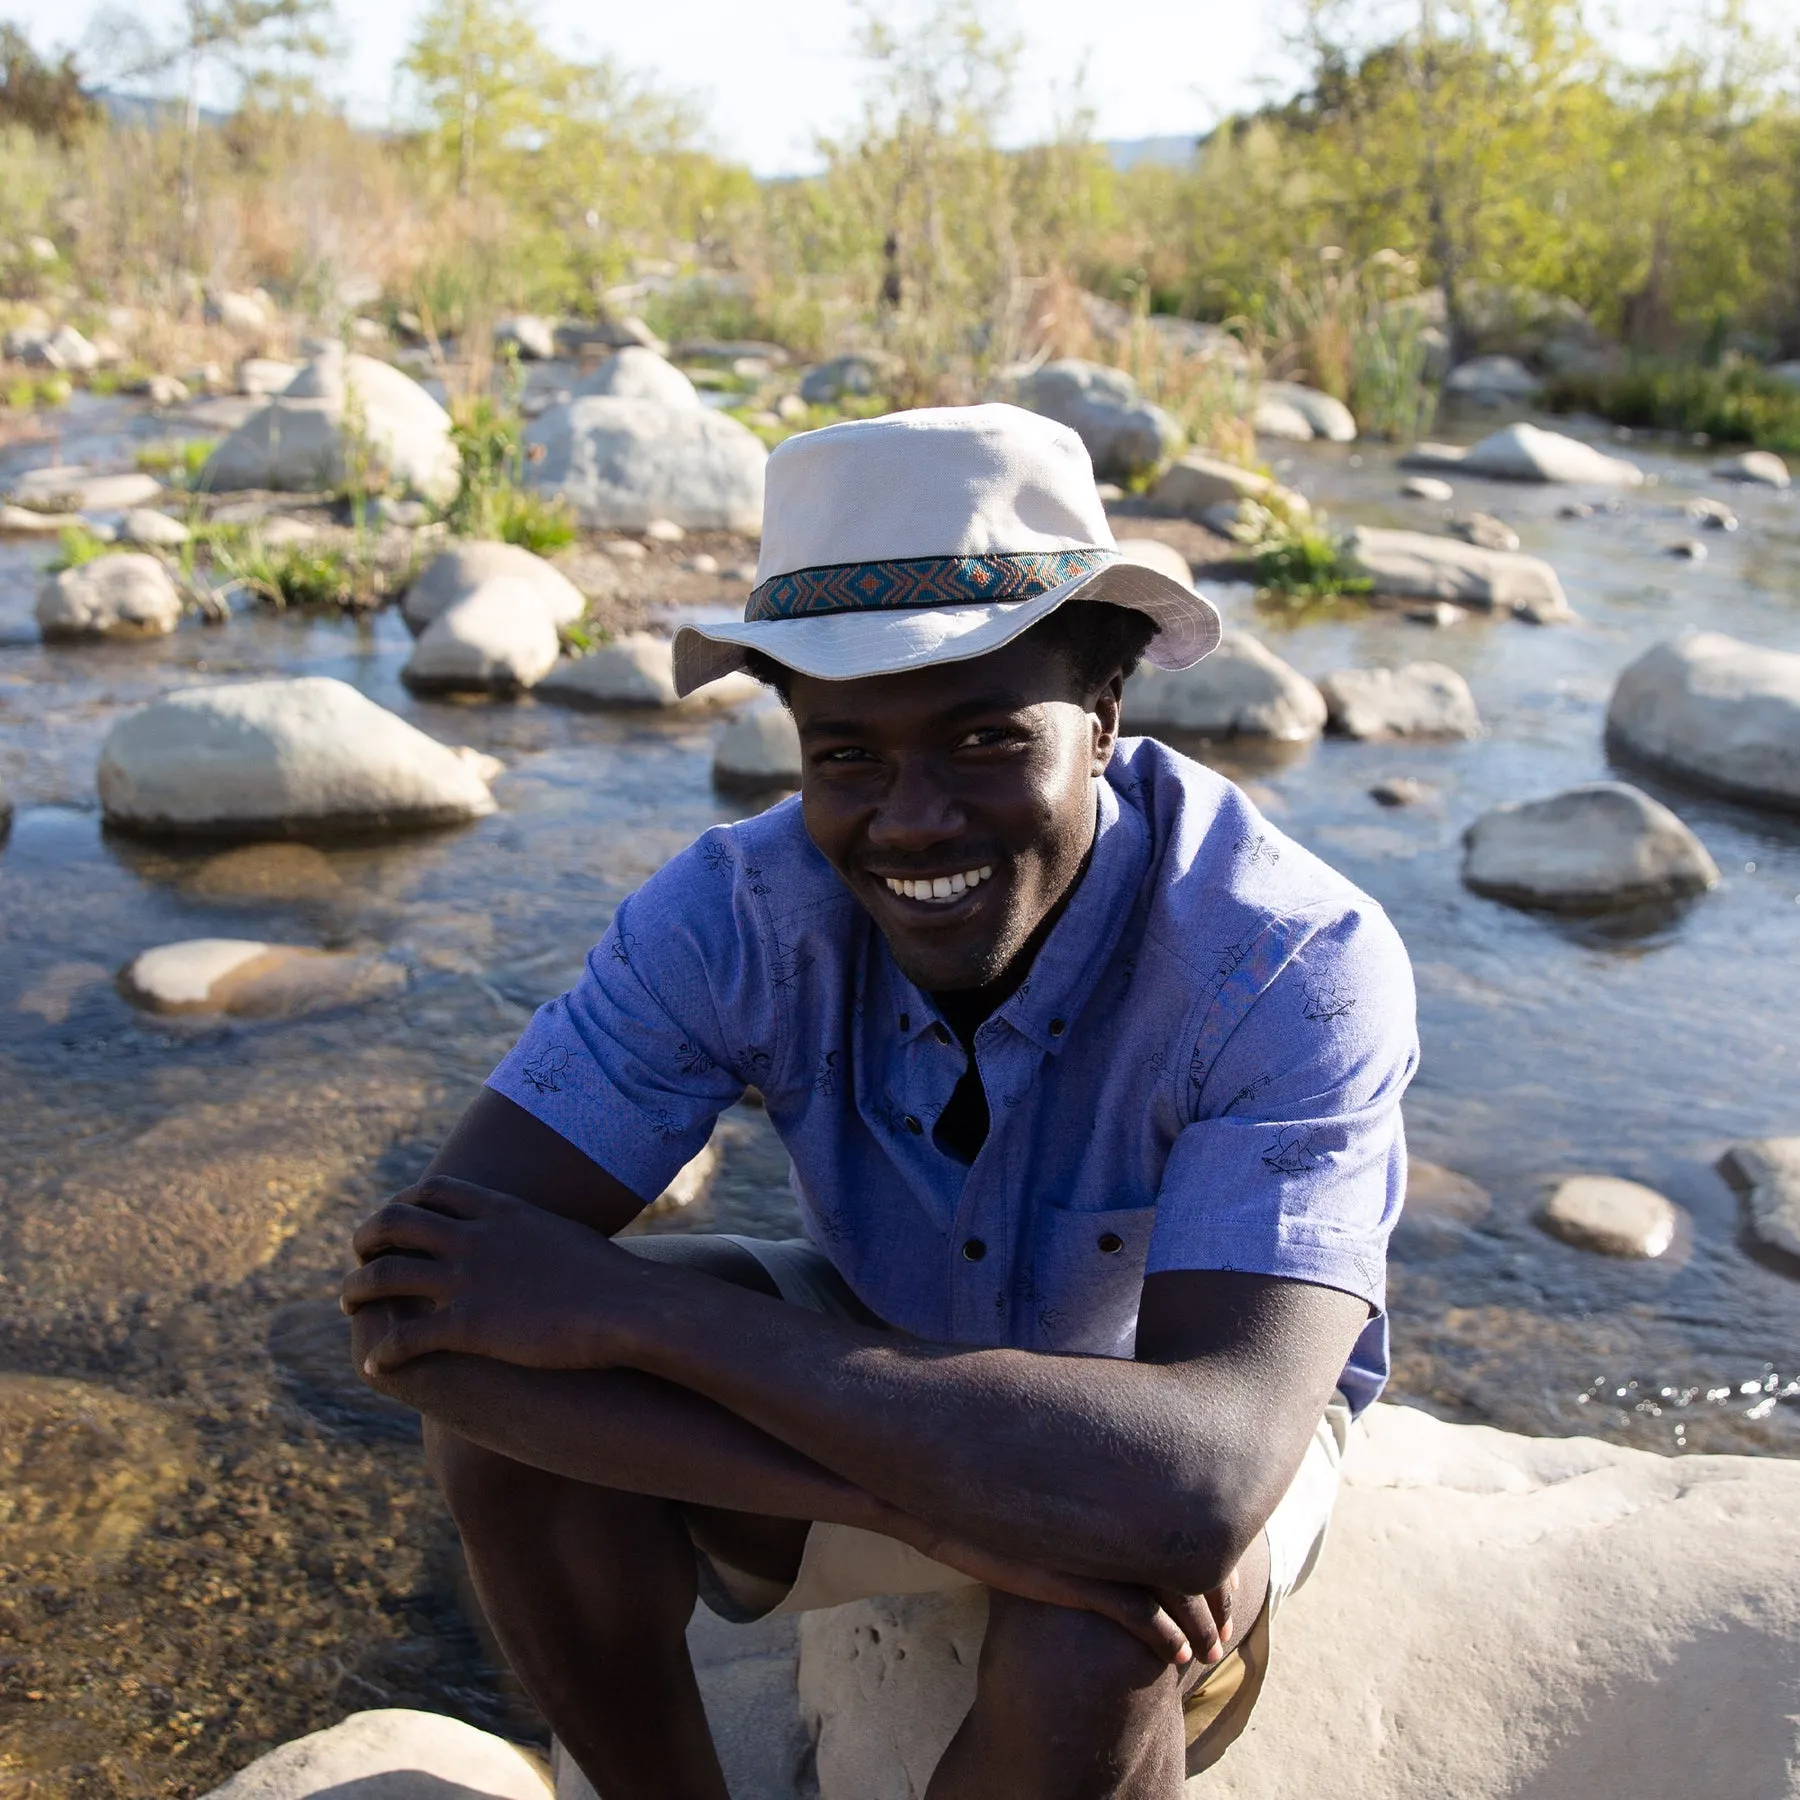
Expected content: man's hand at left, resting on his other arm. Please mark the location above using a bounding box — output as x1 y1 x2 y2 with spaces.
342 1175 650 1381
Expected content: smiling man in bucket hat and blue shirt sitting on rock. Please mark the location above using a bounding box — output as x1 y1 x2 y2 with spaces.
346 407 1417 1800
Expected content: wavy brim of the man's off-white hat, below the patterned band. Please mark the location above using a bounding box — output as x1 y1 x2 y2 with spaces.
675 562 1220 698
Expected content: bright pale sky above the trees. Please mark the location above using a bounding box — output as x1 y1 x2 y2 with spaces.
0 0 1795 175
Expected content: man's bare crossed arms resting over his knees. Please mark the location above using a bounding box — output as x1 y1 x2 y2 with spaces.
344 1091 1366 1656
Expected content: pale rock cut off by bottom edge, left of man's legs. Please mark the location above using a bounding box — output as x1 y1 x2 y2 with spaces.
205 1706 553 1800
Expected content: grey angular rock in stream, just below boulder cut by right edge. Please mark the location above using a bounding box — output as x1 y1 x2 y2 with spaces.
1463 781 1719 913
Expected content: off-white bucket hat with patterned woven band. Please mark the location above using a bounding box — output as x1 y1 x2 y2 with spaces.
675 405 1219 695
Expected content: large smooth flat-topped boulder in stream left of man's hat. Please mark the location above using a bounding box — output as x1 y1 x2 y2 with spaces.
99 675 500 837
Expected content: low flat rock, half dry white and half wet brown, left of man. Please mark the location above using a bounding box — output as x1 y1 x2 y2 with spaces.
119 938 407 1019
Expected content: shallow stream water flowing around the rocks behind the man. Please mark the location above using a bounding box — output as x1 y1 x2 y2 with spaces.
0 403 1800 1795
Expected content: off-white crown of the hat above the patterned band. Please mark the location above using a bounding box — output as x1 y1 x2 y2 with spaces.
756 403 1112 587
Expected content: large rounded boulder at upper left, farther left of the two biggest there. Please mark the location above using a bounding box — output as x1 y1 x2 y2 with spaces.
200 346 459 500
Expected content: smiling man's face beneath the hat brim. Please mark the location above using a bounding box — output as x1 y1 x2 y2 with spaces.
788 635 1120 994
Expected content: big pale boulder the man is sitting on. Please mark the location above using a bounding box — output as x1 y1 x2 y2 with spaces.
799 1406 1800 1800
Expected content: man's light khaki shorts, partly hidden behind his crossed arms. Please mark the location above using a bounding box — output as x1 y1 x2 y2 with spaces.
617 1233 1350 1775
